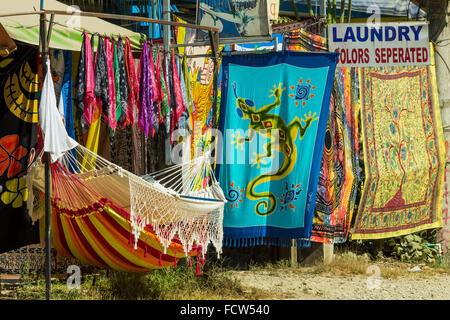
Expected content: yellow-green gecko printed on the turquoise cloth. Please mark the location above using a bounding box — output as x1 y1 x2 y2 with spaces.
232 83 319 216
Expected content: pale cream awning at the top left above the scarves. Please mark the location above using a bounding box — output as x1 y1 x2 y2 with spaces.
0 0 141 51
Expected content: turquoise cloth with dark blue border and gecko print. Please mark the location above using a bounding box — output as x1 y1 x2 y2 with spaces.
216 51 338 245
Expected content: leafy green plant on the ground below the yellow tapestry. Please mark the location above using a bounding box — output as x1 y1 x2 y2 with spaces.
386 233 439 264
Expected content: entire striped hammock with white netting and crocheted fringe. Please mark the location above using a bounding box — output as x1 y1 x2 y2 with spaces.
28 145 226 271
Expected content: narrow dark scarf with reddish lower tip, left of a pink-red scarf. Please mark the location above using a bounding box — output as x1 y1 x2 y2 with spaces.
116 38 128 129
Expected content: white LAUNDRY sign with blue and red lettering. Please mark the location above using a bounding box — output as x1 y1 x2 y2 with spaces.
328 22 430 67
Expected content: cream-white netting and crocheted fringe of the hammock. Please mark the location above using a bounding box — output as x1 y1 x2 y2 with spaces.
27 145 226 255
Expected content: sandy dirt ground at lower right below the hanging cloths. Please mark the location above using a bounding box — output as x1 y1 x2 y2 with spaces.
231 270 450 300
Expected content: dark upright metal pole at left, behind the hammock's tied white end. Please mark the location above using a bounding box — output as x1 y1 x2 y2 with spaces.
39 0 51 300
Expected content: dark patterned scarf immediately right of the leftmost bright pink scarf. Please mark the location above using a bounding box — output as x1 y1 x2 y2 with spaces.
94 37 110 123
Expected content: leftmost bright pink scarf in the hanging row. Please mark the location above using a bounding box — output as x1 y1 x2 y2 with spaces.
83 31 96 125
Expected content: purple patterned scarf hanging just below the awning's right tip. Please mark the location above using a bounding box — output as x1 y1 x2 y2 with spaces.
139 42 153 138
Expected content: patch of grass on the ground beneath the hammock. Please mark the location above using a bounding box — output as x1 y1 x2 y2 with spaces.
11 255 270 300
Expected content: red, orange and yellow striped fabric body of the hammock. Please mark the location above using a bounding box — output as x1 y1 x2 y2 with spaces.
52 192 201 272
